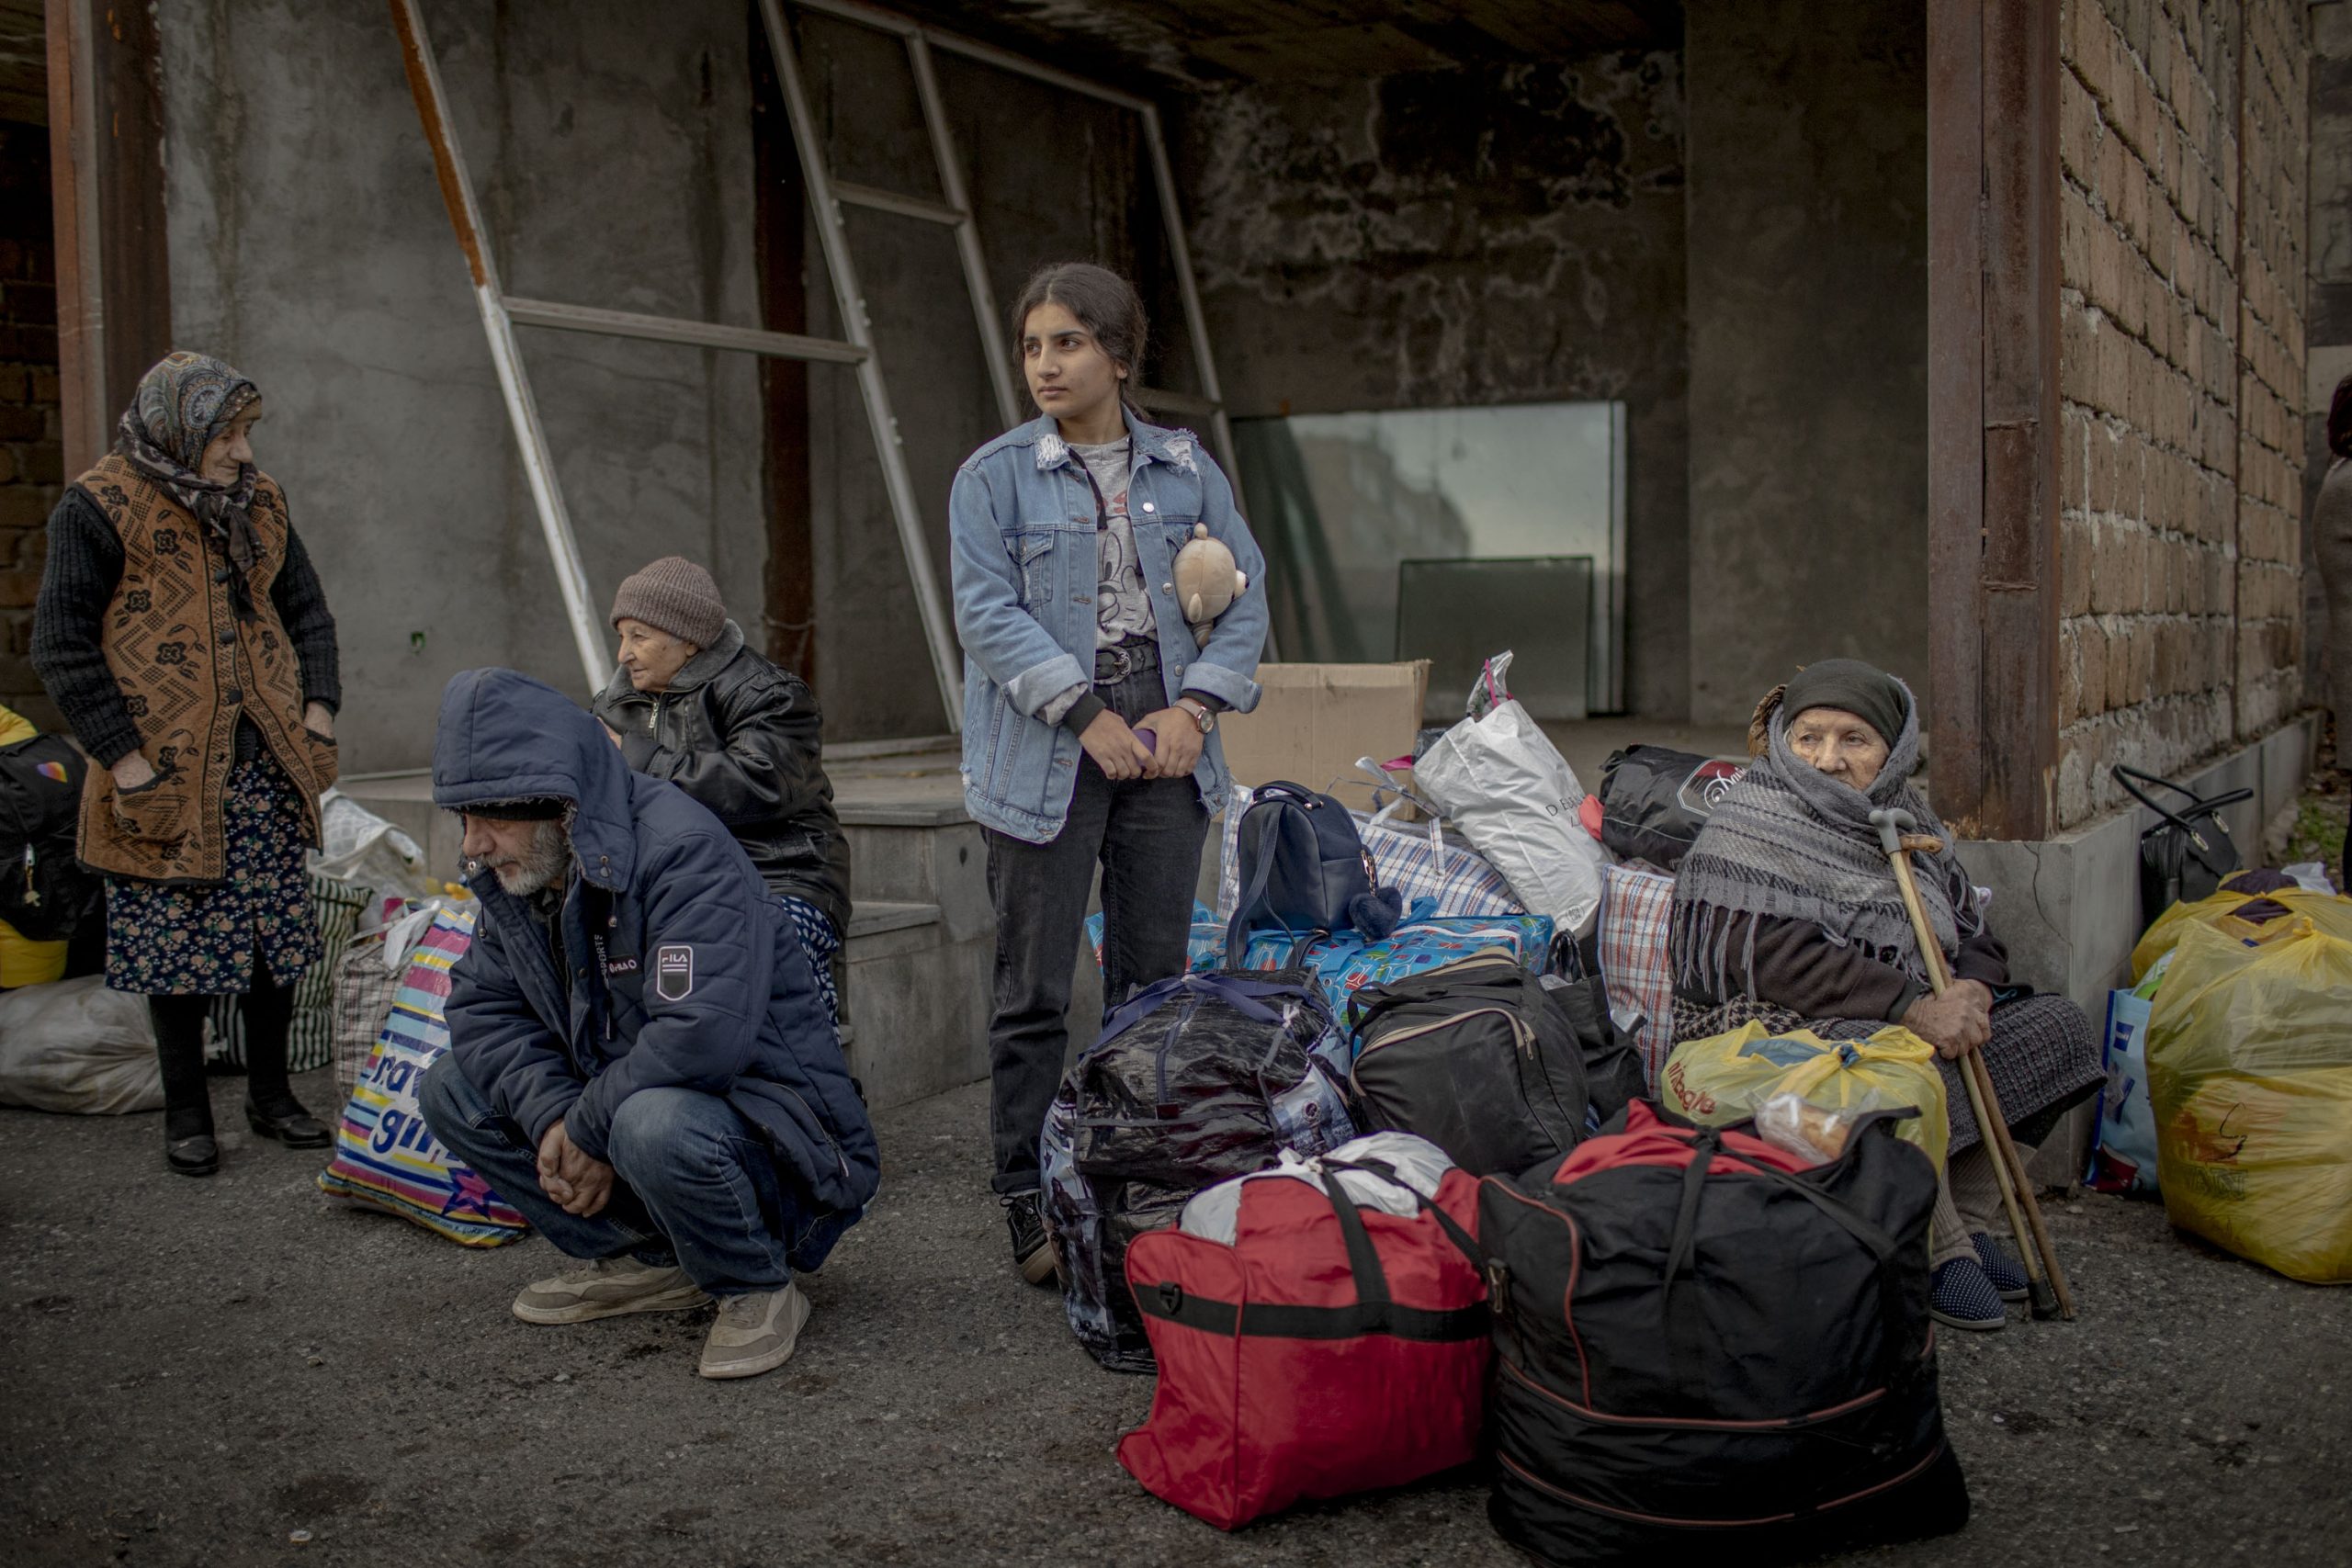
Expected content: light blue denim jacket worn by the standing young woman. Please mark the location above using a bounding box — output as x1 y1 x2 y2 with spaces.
948 413 1268 844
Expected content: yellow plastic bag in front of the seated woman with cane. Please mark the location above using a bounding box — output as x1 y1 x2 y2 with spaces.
1658 1022 1952 1170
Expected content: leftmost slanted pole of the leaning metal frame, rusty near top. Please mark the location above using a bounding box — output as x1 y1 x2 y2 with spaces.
390 0 612 691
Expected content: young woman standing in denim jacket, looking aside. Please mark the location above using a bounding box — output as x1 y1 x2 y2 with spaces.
948 264 1265 1283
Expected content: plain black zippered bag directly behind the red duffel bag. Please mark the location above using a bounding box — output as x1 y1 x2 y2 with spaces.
1348 947 1616 1176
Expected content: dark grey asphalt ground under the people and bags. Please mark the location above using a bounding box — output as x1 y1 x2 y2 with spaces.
0 1075 2352 1568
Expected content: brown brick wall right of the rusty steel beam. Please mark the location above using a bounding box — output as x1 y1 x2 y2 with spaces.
2058 0 2310 825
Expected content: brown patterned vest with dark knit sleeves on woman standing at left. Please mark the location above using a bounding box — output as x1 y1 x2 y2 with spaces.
33 454 341 882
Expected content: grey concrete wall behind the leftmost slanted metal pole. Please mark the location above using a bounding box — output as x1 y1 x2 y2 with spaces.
158 0 767 771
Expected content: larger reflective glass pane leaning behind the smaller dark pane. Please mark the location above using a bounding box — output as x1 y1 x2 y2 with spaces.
1232 402 1625 712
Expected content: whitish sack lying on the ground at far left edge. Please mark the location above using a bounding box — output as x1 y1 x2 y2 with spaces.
0 976 163 1117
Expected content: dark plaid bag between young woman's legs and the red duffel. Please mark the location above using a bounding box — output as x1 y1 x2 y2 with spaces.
1040 974 1357 1373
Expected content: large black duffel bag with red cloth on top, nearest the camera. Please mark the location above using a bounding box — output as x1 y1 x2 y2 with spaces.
1479 1100 1969 1565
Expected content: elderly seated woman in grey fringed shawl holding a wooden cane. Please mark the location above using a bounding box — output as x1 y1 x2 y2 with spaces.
1672 659 2100 1328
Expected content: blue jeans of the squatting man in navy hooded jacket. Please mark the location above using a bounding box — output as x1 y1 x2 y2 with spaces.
416 1055 844 1295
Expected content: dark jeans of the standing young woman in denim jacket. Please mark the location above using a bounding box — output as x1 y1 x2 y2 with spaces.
988 668 1209 1192
